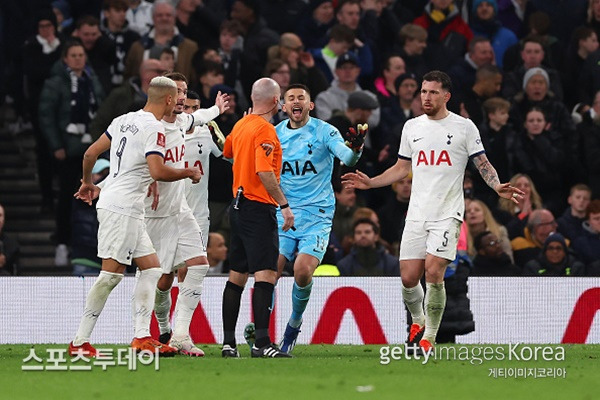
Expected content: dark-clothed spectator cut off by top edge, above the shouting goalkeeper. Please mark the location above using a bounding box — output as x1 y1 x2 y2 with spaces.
296 0 336 49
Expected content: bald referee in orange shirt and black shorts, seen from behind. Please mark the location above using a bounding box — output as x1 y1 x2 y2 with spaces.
221 78 294 358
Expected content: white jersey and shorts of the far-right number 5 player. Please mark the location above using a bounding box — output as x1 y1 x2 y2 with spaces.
398 112 485 260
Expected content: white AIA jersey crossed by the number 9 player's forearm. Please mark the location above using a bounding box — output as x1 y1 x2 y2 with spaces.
144 114 192 218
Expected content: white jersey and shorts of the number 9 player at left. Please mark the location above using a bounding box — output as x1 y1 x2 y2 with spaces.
96 110 166 265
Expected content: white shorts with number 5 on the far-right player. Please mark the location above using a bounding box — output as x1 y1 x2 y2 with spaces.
400 218 461 261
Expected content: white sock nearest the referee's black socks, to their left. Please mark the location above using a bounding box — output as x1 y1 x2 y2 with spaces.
173 264 209 338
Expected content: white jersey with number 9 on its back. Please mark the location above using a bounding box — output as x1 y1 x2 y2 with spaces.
96 110 166 219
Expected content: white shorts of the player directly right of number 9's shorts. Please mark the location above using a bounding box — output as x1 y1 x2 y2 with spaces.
146 211 206 274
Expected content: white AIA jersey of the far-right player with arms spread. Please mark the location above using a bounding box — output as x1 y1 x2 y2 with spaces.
398 112 485 221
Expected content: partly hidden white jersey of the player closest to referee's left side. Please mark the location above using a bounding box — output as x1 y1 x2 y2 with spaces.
184 125 223 219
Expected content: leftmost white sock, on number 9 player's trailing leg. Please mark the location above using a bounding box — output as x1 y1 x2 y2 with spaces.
73 271 123 346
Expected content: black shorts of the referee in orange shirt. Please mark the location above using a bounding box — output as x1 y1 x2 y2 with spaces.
229 196 279 273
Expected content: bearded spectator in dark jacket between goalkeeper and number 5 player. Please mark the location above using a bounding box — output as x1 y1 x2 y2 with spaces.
337 218 400 276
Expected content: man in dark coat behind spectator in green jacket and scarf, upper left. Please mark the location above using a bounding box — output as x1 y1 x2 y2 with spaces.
73 15 119 93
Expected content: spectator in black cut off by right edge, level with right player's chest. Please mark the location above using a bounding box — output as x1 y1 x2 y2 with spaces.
577 90 600 198
